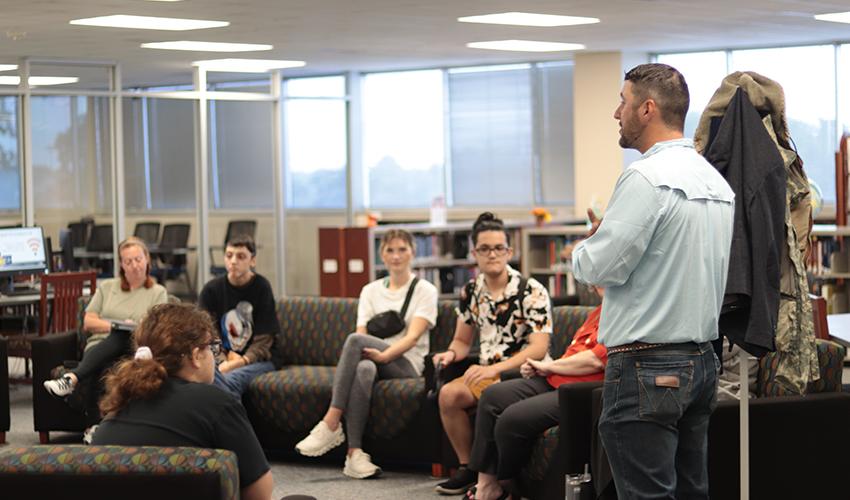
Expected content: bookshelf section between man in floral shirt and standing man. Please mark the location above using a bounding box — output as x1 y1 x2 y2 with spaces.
522 224 587 298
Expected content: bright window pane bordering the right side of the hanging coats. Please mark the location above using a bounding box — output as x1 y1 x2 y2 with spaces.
731 45 836 203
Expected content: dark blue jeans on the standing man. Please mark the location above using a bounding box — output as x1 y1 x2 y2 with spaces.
599 342 720 500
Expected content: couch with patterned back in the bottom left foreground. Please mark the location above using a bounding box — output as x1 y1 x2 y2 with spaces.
0 445 239 500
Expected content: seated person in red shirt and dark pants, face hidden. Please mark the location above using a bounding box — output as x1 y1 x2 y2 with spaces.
466 288 608 500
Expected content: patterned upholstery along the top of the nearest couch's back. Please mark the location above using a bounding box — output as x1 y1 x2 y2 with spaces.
0 445 239 499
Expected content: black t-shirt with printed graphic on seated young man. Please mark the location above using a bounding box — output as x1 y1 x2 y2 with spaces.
198 274 280 367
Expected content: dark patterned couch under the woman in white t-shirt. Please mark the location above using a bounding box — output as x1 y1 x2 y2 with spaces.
243 297 456 464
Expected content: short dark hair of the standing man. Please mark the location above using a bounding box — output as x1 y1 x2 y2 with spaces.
625 63 691 131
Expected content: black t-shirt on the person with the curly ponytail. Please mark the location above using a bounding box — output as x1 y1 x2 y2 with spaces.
92 378 269 487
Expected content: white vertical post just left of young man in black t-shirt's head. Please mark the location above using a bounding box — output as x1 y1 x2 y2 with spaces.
192 66 210 290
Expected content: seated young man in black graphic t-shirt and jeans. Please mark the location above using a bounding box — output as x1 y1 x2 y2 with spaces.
198 236 280 400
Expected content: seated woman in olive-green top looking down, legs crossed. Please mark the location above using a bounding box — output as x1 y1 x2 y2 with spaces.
44 236 168 442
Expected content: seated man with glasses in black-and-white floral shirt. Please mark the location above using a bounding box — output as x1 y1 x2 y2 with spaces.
433 212 552 495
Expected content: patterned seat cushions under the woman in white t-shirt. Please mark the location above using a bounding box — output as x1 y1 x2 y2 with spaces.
248 366 425 439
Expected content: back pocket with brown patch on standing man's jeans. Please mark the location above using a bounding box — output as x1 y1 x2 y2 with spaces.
635 360 694 424
